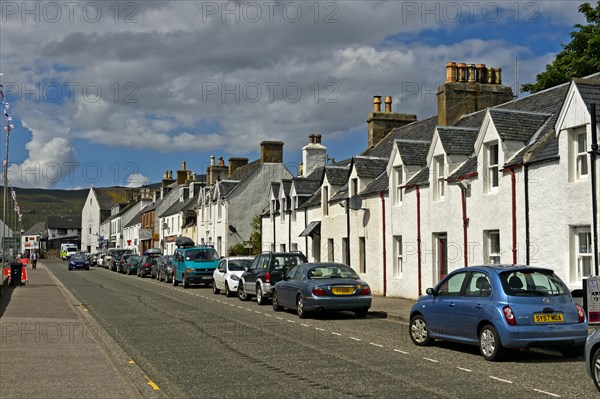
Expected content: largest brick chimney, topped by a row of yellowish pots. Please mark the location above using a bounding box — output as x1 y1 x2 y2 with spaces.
437 62 514 126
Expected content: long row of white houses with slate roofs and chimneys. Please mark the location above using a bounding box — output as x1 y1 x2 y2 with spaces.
82 63 600 298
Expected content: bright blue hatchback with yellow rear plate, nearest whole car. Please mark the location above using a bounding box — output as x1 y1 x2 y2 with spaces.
409 265 587 360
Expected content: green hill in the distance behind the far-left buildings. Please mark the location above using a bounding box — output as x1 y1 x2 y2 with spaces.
0 186 90 230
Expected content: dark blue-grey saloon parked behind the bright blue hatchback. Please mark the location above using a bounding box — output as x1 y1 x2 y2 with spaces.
273 263 372 319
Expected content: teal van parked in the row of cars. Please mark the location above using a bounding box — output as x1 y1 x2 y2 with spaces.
172 237 220 288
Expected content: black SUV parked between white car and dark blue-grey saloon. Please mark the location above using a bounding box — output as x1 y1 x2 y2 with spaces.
238 252 308 305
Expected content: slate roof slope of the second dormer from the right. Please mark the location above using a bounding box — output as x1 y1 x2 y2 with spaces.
489 108 551 142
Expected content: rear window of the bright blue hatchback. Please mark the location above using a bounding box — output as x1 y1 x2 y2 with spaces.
500 270 569 296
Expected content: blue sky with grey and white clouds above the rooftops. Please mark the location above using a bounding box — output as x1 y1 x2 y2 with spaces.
0 0 595 189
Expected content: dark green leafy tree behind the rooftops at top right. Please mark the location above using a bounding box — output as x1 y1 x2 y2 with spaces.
521 0 600 93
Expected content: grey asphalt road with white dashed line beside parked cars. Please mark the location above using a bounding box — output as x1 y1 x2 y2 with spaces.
45 261 598 399
